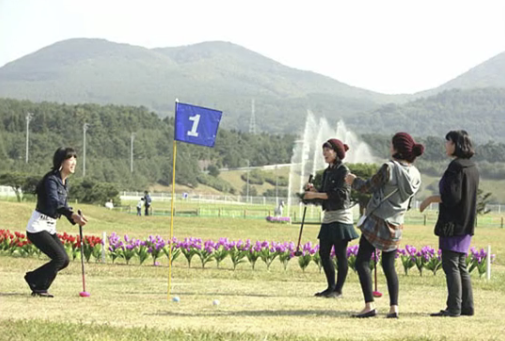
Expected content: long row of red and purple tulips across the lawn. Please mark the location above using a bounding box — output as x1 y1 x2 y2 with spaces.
0 230 496 276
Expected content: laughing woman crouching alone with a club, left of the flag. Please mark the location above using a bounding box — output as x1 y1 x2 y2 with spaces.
25 148 87 297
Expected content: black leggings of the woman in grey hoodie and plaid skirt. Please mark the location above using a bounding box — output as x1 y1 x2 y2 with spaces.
356 235 399 305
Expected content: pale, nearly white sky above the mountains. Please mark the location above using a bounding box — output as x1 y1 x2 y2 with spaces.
0 0 505 93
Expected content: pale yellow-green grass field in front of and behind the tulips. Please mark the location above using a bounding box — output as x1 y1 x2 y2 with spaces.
0 202 505 341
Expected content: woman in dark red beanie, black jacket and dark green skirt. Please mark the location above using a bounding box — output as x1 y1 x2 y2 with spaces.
304 139 358 298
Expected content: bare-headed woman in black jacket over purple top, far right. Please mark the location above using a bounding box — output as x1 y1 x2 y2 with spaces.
420 130 479 317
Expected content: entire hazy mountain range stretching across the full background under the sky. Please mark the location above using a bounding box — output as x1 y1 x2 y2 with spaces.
0 38 505 141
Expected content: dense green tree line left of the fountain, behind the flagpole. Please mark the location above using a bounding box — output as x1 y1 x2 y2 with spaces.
0 99 295 190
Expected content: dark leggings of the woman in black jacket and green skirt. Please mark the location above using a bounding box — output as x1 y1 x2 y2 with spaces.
319 239 349 293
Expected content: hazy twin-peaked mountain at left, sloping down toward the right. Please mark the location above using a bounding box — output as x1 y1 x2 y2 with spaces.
0 39 405 132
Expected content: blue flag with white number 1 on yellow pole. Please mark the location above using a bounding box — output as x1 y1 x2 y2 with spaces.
175 102 223 147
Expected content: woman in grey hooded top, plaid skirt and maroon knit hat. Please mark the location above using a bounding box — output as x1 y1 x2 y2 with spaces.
346 133 424 318
